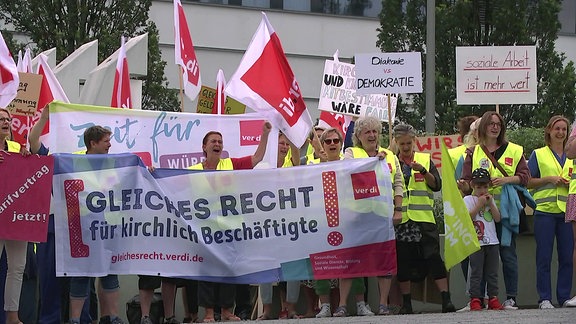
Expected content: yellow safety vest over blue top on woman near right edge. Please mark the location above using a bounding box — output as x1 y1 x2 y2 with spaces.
530 146 572 213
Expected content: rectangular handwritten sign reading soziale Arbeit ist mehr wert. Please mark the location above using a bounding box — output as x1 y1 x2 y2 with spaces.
456 46 537 105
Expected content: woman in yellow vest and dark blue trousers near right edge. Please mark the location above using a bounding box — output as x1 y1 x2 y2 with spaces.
528 116 576 309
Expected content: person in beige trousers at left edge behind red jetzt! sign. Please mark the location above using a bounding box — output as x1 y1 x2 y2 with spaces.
0 108 30 324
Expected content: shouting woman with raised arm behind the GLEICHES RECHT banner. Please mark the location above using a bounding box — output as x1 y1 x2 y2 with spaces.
188 122 272 323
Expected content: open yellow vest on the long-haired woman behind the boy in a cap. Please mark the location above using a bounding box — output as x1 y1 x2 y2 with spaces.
472 142 524 208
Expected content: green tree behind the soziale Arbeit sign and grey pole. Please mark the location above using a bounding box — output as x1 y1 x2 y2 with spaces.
376 0 576 133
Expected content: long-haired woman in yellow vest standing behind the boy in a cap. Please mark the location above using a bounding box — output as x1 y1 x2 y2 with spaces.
458 111 530 310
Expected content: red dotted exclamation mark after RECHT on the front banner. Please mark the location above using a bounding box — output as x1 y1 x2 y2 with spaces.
322 171 344 246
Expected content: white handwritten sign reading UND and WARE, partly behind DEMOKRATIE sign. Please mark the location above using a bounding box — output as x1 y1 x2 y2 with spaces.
318 60 397 122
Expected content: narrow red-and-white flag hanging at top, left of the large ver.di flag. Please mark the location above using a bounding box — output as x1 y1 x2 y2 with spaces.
174 0 202 100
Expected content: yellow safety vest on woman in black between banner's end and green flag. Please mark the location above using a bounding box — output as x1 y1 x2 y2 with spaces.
402 152 436 224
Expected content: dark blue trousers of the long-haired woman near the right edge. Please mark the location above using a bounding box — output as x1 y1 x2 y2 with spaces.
534 211 574 305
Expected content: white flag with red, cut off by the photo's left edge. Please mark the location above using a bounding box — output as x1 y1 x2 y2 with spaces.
0 33 20 108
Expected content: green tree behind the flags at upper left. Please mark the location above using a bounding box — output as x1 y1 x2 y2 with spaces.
0 0 179 111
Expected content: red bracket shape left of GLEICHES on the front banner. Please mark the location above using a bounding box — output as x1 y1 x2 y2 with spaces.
64 179 90 258
